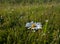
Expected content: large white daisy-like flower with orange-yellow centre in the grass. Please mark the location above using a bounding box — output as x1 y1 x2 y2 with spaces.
25 21 42 30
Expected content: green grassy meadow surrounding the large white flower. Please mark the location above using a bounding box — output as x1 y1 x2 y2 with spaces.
0 0 60 44
